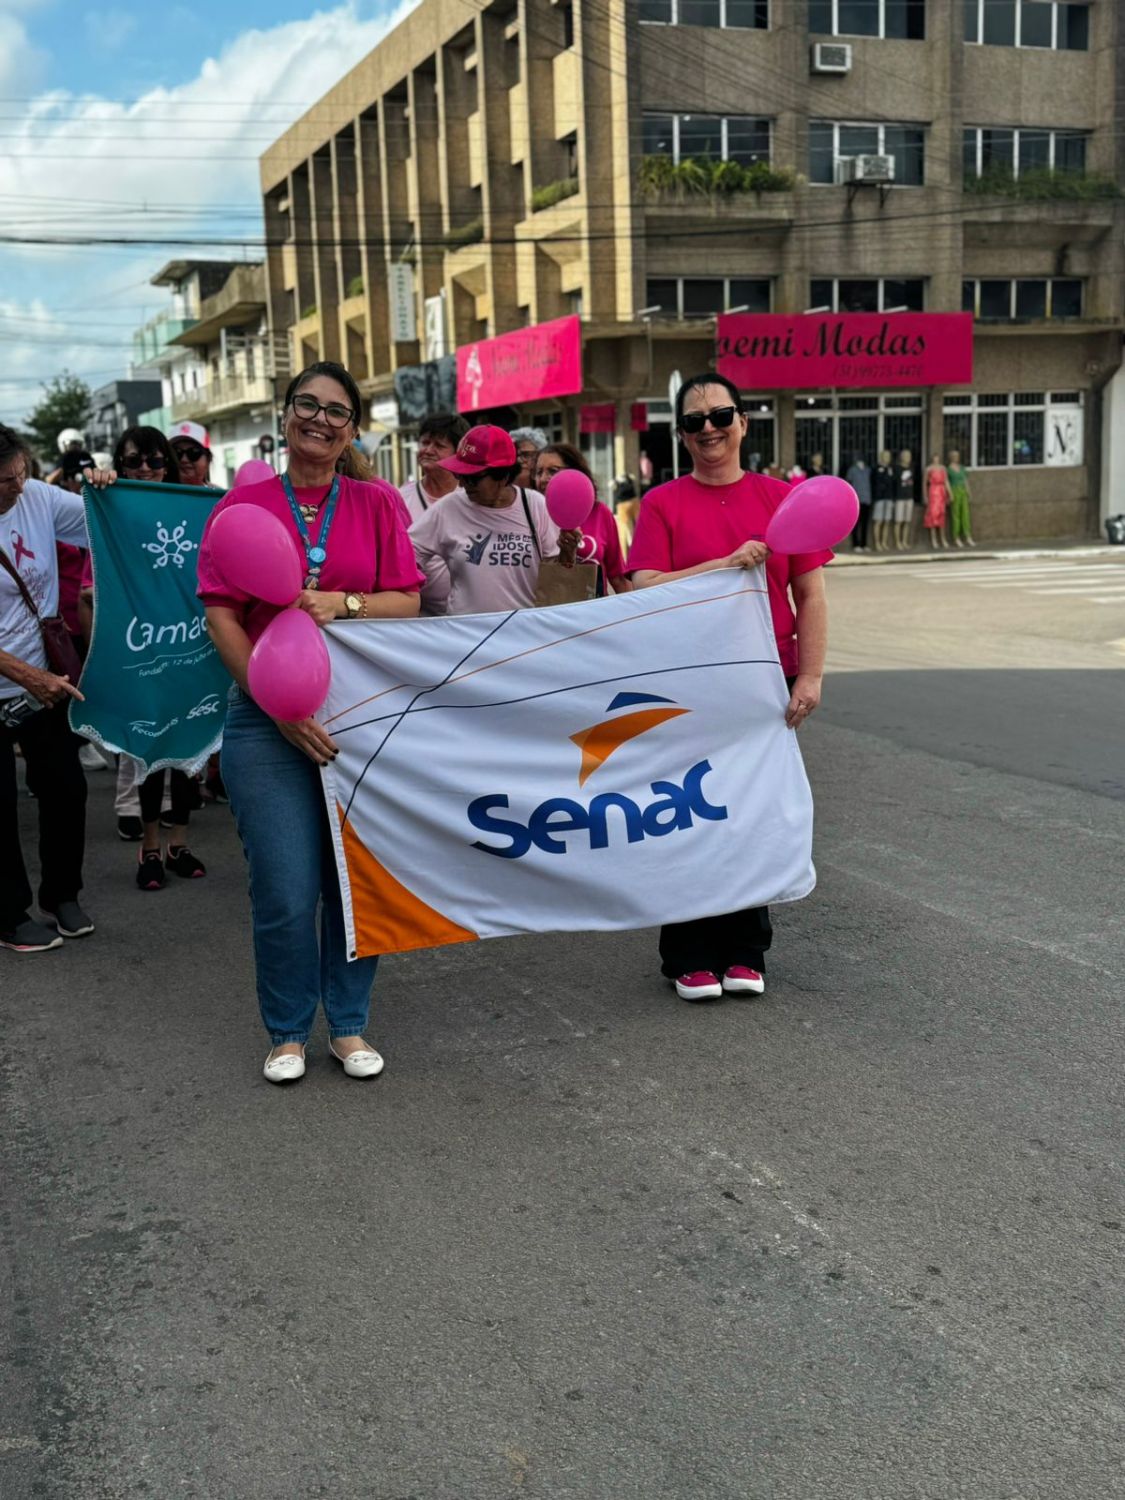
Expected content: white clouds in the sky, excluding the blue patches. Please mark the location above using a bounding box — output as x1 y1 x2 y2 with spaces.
0 0 414 420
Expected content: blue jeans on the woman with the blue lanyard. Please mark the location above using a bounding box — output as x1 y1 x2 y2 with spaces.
222 692 378 1047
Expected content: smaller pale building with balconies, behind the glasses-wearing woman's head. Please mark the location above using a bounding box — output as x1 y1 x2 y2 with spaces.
134 261 288 485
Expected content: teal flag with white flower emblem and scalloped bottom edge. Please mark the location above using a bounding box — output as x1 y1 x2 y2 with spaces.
71 480 231 774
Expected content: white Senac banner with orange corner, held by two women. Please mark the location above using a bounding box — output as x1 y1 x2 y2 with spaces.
318 569 816 957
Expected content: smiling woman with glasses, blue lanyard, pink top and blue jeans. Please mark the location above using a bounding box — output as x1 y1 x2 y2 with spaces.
198 362 422 1083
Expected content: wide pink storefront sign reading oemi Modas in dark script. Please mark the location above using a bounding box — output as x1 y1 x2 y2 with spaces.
716 312 972 390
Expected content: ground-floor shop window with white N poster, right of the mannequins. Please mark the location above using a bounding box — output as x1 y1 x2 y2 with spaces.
944 390 1083 468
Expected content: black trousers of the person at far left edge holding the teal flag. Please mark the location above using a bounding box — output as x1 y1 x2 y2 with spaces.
0 698 86 929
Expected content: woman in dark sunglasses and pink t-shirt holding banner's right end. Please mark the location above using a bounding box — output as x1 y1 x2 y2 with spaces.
629 374 833 1001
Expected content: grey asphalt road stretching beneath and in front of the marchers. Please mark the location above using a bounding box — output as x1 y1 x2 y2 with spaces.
0 564 1125 1500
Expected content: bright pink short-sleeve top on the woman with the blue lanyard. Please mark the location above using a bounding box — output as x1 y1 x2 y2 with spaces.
197 477 423 641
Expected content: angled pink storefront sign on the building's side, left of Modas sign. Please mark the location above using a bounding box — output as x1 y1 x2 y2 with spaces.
458 317 582 413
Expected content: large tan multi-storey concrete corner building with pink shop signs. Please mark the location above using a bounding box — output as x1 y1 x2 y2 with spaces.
261 0 1125 539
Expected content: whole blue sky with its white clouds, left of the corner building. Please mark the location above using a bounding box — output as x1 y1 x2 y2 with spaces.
0 0 413 422
